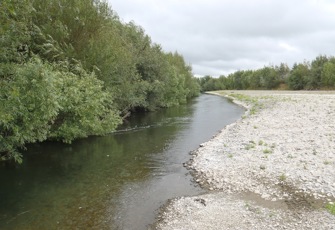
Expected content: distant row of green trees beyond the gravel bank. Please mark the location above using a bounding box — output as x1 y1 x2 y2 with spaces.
199 55 335 91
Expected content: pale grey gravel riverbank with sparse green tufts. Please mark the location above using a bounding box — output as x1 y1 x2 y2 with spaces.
156 91 335 229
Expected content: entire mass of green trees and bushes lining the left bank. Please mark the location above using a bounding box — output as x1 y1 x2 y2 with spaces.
0 0 199 161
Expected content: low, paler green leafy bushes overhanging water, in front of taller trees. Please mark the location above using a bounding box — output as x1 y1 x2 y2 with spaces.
0 58 120 160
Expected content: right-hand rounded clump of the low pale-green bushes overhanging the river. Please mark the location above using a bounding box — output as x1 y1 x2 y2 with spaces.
48 62 121 143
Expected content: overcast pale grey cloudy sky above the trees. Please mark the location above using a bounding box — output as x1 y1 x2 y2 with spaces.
108 0 335 76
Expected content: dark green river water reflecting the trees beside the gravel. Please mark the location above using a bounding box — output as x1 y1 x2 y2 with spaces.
0 95 244 230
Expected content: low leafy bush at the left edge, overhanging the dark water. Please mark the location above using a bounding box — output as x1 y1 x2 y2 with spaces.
0 58 59 161
